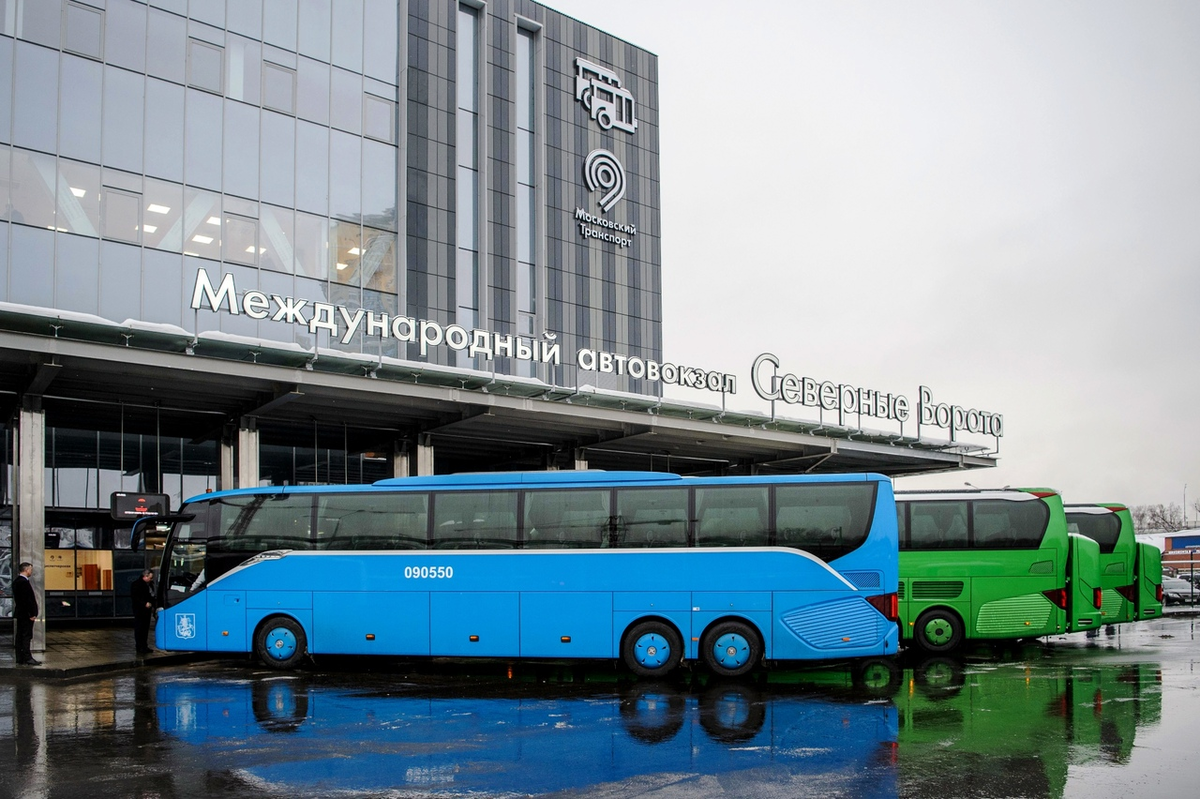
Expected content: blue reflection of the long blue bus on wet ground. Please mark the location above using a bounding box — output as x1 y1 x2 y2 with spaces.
156 675 896 797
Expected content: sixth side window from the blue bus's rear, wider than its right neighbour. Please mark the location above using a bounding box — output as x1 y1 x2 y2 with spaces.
317 493 430 549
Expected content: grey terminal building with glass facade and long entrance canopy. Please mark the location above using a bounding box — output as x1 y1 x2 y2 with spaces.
0 0 995 619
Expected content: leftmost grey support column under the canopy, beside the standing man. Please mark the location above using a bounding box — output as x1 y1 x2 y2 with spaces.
12 396 46 651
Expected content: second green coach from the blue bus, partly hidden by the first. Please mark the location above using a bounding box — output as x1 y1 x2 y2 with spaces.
1064 503 1142 624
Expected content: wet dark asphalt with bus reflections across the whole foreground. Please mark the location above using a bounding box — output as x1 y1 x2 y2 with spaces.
0 615 1200 799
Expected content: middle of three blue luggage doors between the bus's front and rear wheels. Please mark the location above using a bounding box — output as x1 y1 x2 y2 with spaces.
430 591 521 657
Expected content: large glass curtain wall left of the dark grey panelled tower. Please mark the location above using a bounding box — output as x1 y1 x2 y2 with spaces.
0 0 398 354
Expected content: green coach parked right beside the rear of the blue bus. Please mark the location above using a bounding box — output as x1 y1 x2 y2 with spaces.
896 488 1080 653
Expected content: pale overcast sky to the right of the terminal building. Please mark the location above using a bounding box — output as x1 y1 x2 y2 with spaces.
547 0 1200 506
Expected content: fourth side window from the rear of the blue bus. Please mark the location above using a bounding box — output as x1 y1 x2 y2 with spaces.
524 489 611 549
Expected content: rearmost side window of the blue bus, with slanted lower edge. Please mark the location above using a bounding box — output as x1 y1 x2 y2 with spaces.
775 483 875 560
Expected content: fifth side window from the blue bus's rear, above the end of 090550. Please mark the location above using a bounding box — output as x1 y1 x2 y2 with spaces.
431 491 517 549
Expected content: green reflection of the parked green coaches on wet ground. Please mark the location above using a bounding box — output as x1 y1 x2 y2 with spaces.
894 659 1162 797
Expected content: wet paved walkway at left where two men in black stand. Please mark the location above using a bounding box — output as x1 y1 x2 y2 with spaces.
0 625 208 677
